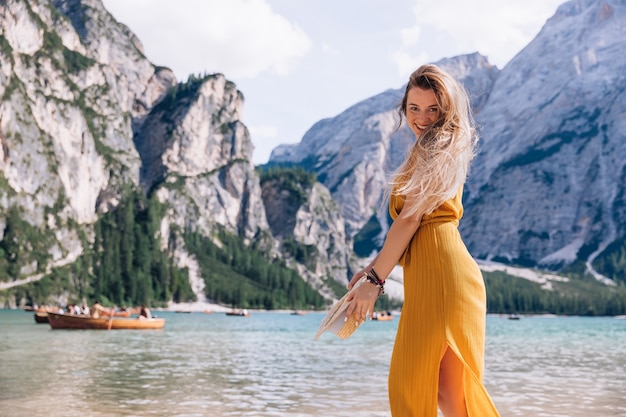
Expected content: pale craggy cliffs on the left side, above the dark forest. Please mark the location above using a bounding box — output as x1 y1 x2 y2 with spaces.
0 0 350 301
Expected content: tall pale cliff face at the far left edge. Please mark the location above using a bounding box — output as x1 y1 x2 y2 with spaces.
0 1 174 272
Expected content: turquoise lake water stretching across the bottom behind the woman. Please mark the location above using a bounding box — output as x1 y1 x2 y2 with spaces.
0 310 626 417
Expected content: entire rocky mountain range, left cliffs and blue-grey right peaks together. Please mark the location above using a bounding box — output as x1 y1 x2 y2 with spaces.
0 0 626 305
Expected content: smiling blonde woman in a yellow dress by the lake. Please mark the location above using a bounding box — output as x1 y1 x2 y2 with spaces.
346 65 498 417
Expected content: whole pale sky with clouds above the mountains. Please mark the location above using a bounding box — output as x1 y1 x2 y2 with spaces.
103 0 565 165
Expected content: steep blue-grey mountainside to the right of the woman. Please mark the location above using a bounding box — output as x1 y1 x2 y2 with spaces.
462 0 626 266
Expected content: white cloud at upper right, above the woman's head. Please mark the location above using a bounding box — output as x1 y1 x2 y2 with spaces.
393 0 563 75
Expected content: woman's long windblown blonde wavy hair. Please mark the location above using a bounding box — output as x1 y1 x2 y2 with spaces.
386 65 478 216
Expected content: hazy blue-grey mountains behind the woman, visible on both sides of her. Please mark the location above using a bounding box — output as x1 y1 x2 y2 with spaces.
270 0 626 280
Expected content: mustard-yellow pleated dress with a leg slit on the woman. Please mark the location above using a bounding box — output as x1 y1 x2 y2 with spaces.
389 187 499 417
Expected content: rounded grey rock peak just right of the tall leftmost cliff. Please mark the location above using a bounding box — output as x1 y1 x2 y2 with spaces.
135 74 269 243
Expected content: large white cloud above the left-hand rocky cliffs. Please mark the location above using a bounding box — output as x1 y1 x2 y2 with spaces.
104 0 312 80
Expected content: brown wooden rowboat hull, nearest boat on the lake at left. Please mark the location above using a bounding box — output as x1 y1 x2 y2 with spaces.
48 312 165 330
